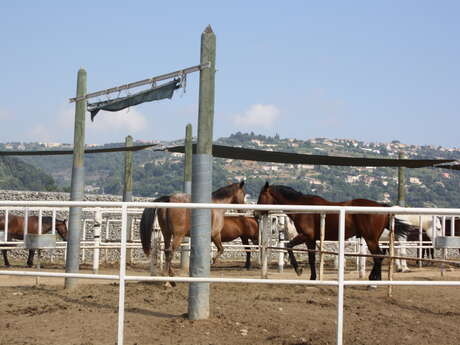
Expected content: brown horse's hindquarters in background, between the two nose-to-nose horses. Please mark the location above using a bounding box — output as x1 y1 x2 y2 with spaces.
220 216 259 270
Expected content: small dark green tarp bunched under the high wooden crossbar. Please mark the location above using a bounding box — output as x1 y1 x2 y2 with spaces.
88 79 180 121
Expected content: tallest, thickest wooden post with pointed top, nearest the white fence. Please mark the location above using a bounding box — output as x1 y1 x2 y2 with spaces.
188 25 216 320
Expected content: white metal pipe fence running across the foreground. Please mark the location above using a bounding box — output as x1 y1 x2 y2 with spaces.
0 201 460 345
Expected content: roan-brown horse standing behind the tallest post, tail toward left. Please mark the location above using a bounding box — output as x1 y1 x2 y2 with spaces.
139 181 246 277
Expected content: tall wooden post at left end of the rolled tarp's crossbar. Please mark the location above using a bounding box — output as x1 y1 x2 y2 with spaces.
64 68 86 289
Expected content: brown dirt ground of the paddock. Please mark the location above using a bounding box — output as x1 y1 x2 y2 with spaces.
0 263 460 345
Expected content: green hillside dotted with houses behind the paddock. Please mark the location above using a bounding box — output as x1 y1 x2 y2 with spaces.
0 133 460 207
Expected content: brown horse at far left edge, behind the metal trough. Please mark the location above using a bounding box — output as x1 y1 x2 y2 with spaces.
0 215 67 267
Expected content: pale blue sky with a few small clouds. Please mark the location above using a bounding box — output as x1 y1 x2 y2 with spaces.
0 0 460 147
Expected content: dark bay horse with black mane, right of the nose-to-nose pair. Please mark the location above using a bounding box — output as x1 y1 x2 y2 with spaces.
257 182 406 280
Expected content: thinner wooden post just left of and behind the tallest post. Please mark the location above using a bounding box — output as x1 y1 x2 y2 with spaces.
180 123 193 271
